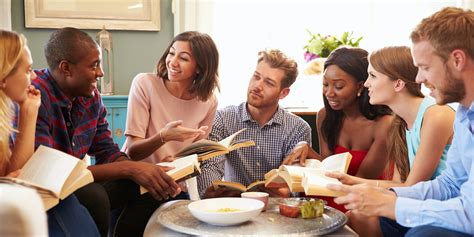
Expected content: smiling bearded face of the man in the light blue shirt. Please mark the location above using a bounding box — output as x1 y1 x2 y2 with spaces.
412 40 466 104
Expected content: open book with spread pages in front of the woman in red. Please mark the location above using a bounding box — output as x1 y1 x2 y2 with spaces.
265 152 352 196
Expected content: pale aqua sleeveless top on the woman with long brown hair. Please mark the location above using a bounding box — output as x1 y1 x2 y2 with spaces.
405 96 450 179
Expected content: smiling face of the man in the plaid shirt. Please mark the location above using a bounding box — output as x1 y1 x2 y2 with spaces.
63 47 104 98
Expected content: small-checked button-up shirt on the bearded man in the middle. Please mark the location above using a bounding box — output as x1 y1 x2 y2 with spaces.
197 103 311 196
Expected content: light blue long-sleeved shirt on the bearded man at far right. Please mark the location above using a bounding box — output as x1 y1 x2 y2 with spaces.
393 103 474 235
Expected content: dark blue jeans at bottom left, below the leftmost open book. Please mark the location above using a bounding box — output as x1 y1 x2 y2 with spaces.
47 194 100 237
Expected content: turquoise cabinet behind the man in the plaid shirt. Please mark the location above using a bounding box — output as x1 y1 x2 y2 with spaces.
102 95 128 148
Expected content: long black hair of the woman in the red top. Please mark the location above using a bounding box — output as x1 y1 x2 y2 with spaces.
321 47 391 151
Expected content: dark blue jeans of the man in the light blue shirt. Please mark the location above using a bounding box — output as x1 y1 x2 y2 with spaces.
379 217 469 237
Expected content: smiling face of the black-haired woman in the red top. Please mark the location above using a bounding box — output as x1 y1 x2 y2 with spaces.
323 65 362 110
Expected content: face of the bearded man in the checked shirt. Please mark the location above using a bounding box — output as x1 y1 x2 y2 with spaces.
247 61 289 108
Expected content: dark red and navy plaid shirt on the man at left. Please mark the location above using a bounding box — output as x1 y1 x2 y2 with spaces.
32 69 120 164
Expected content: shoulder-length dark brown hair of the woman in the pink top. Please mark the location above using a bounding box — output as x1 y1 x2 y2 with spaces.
156 31 219 101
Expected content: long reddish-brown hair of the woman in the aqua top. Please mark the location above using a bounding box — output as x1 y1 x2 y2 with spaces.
369 46 424 182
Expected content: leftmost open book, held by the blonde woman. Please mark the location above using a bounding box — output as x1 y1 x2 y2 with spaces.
0 145 94 210
